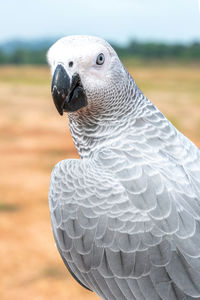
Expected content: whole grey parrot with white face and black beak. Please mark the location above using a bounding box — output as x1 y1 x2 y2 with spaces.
48 36 200 300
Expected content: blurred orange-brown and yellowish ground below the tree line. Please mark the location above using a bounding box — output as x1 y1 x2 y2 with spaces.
0 64 200 300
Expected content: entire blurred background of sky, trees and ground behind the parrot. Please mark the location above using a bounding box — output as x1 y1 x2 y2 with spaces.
0 0 200 300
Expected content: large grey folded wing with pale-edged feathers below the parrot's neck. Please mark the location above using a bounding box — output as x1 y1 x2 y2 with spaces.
49 131 200 300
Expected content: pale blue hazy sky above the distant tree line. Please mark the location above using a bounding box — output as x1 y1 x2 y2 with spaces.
0 0 200 43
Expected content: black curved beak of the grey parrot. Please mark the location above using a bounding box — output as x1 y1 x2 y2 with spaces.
51 65 87 115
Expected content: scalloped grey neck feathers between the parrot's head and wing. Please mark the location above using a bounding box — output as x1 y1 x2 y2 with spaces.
68 82 149 158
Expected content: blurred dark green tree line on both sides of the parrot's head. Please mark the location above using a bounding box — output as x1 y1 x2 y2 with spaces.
0 40 200 65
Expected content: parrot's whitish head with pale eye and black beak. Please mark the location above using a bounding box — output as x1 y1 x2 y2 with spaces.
47 36 129 115
